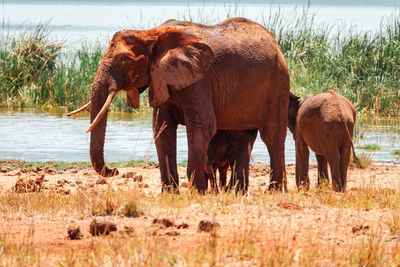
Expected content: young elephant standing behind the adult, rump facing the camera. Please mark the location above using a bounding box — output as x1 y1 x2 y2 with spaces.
288 90 361 192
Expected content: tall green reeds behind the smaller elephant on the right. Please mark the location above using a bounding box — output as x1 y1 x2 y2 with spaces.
264 9 400 115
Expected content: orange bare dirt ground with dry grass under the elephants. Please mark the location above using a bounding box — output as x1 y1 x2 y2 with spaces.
0 163 400 266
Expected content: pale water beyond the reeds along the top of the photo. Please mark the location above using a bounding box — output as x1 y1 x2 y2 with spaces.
0 0 400 47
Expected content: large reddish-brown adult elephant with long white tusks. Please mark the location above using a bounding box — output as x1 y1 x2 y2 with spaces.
67 18 290 192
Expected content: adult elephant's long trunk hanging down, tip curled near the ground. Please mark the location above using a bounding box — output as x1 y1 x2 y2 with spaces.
88 73 118 177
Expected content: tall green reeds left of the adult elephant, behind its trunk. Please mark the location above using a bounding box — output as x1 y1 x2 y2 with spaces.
0 24 148 112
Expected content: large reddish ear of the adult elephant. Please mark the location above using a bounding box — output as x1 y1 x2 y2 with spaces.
150 36 214 106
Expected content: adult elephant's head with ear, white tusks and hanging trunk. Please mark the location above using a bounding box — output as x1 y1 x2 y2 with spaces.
70 27 214 176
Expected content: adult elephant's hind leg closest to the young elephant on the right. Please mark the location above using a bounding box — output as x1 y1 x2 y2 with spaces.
260 101 289 191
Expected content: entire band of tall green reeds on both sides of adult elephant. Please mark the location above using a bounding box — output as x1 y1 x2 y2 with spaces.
0 8 400 116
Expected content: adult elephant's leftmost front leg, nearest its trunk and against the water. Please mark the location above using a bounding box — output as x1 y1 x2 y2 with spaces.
153 108 179 193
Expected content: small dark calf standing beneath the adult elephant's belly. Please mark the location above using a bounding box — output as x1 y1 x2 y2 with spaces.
206 129 257 193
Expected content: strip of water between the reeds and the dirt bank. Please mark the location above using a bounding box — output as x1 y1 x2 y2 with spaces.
0 112 400 166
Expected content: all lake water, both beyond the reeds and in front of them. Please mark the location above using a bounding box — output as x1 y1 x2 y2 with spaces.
0 0 400 164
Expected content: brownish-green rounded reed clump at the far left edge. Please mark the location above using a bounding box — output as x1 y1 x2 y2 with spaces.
0 24 62 108
